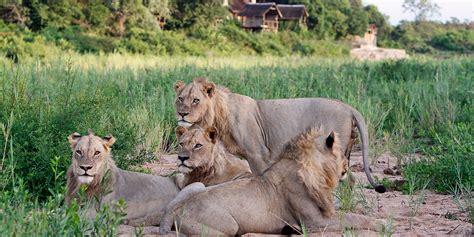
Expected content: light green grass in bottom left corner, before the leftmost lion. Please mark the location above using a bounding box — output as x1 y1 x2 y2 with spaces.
0 159 126 236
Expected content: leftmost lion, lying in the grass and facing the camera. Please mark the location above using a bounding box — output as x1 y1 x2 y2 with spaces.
65 130 179 226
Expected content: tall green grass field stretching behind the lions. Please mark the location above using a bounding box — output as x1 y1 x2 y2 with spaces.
0 54 474 233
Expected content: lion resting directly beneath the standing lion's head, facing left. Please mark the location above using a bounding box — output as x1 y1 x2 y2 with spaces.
176 126 251 188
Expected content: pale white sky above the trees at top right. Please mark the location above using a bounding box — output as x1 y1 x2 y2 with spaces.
362 0 474 25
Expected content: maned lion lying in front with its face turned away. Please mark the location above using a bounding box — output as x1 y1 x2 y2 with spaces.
160 128 383 236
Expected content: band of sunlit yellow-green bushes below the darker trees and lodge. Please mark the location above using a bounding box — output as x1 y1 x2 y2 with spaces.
0 20 348 57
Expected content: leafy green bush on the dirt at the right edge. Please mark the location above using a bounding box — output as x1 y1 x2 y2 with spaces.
403 123 474 193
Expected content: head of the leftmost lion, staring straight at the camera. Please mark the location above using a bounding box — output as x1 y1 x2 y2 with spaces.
68 130 115 185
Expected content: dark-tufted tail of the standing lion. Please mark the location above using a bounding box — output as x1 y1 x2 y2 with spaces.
352 109 385 193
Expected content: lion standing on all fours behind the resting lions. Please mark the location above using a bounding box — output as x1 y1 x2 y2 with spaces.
174 78 385 193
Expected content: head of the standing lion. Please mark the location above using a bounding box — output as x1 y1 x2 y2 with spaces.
174 78 228 128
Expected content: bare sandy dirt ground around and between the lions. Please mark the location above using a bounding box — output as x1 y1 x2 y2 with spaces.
119 152 474 237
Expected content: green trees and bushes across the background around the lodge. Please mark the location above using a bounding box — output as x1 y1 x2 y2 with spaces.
0 0 474 55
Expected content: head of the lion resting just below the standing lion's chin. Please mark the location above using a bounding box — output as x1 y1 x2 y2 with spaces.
176 126 217 174
